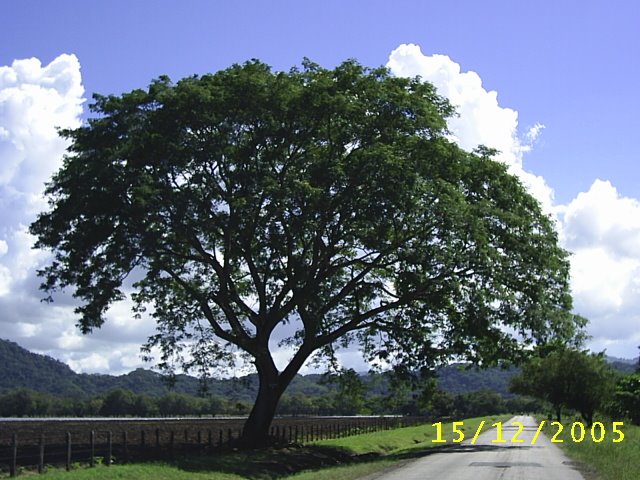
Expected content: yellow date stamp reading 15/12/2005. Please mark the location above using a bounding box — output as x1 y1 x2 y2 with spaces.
431 420 624 445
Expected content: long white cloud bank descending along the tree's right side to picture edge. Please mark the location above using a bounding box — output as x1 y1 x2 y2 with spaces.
387 45 640 357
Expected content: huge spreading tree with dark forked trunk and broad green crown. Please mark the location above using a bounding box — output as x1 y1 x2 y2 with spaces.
31 61 576 443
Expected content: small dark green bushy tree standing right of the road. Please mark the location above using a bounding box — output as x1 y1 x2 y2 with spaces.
511 348 615 425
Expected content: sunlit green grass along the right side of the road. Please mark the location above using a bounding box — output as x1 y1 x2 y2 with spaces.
545 420 640 480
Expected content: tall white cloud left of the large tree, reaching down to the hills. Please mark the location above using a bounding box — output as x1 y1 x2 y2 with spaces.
0 55 158 372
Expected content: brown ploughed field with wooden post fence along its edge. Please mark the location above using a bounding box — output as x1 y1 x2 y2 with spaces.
0 417 428 477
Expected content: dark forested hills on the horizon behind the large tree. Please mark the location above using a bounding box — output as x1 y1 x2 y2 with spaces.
0 339 630 401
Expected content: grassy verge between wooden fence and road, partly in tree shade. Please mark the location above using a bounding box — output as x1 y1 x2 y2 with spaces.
25 415 510 480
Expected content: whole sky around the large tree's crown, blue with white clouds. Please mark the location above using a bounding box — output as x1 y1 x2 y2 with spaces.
0 0 640 371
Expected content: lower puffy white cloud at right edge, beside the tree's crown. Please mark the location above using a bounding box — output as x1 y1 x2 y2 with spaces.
560 179 640 356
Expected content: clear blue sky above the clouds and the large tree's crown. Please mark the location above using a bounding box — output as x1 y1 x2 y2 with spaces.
6 0 640 201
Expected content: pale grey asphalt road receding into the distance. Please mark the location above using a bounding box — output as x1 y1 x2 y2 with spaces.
377 416 584 480
